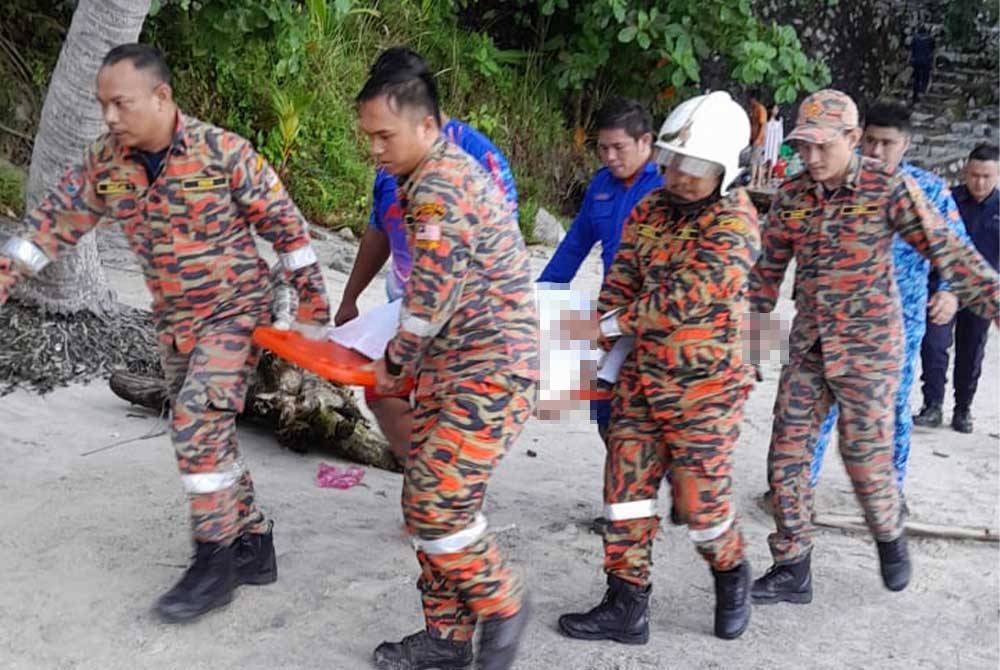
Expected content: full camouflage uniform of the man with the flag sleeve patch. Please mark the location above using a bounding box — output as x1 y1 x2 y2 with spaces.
385 138 538 641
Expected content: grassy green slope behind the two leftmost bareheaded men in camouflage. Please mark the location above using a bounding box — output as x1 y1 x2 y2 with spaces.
145 0 576 236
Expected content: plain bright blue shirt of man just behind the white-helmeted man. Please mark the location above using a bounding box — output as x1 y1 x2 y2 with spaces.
538 161 663 284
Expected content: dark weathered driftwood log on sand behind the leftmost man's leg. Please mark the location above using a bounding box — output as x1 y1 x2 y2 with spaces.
110 352 402 472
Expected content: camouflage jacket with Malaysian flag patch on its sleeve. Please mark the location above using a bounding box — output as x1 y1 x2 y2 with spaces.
386 138 538 390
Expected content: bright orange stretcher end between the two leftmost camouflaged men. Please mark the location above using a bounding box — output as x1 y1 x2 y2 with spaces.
253 327 413 391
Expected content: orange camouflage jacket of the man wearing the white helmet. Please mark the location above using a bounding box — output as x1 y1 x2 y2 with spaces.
598 188 760 383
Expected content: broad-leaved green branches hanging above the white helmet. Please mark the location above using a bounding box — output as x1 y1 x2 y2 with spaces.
462 0 830 110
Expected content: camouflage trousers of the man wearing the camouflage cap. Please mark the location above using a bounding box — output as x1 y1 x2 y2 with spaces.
767 349 902 563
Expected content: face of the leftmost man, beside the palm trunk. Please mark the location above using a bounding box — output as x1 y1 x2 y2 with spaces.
97 61 175 151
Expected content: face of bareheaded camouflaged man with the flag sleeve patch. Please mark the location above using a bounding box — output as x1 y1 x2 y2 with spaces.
358 95 441 176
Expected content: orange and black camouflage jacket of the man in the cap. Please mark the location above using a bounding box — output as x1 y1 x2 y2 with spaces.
750 156 998 376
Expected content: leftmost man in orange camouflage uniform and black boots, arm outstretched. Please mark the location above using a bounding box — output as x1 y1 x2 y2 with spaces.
0 44 330 622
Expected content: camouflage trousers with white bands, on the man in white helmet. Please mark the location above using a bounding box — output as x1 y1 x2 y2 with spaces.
604 363 749 585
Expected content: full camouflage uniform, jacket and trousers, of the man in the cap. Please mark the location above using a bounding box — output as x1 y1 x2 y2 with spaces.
750 156 997 564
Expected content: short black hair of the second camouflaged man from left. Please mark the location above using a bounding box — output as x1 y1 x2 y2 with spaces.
354 47 441 125
